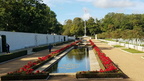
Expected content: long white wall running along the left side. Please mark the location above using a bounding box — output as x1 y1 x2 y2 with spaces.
0 31 75 50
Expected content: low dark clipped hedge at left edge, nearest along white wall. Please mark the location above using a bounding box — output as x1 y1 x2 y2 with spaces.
0 50 27 62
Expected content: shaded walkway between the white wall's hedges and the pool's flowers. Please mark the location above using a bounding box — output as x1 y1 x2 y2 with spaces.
0 43 70 76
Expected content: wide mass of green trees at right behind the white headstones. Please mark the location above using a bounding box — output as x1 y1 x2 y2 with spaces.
98 13 144 39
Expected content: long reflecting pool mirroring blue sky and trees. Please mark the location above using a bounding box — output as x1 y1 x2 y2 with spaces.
47 48 90 73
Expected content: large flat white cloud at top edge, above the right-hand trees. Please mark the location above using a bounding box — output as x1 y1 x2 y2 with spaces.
94 0 134 8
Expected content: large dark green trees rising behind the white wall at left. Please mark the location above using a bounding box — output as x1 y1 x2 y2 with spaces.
0 0 62 33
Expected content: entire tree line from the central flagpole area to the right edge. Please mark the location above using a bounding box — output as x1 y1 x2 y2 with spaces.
63 12 144 39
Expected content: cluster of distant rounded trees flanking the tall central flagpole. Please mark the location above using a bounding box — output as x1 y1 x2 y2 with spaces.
63 17 101 36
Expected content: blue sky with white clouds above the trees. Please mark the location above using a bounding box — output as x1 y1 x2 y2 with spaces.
43 0 144 24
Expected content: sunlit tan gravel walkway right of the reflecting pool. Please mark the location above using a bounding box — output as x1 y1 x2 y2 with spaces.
92 40 144 81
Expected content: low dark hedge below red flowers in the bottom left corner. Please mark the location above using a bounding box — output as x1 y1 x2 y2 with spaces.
1 73 49 81
